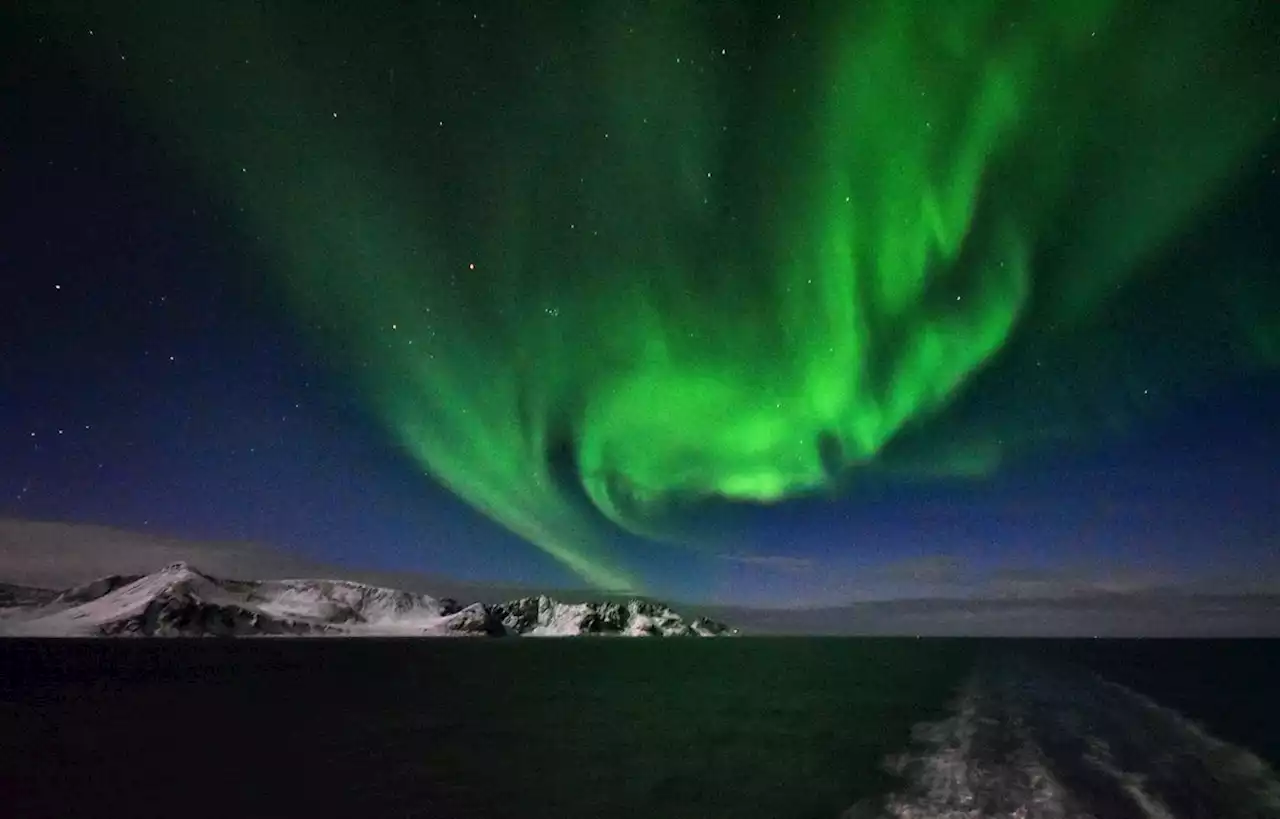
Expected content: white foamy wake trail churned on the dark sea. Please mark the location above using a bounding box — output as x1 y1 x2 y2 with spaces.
842 660 1280 819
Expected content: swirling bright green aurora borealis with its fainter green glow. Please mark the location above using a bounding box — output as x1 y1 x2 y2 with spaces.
2 0 1280 601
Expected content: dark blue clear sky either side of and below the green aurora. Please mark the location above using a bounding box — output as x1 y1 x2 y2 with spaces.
0 4 1280 604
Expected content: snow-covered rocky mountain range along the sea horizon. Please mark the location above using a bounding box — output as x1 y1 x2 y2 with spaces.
0 563 730 636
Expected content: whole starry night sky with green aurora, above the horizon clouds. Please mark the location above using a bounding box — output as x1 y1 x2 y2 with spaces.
0 0 1280 605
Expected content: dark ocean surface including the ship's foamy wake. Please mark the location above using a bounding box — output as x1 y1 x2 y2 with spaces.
0 637 1280 819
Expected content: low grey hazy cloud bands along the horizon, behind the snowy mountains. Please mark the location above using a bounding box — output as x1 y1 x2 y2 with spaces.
0 520 1280 636
